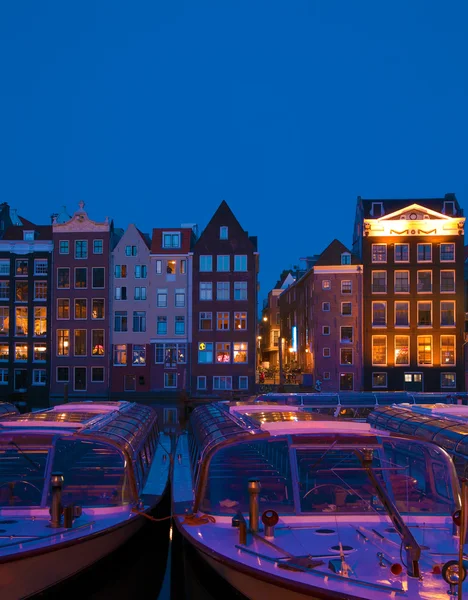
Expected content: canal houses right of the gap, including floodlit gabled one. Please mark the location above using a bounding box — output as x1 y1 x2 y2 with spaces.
279 194 466 393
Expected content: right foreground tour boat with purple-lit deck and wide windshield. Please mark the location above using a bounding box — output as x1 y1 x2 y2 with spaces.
173 403 468 600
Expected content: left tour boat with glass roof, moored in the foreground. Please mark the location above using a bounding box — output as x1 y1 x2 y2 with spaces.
0 402 170 600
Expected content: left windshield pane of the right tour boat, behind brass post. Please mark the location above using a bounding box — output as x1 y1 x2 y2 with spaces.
201 441 294 515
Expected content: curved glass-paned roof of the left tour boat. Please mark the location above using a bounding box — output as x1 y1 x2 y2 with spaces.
0 401 157 452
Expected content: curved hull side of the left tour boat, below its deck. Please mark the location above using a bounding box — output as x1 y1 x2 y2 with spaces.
0 517 143 600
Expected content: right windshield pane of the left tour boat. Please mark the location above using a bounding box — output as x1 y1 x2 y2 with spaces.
49 439 130 507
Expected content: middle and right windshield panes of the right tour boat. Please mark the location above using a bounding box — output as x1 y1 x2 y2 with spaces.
296 438 456 516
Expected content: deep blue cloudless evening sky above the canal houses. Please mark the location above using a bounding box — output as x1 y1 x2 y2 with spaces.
0 0 468 297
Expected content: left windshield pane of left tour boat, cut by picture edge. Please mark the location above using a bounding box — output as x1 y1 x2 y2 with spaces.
0 441 49 509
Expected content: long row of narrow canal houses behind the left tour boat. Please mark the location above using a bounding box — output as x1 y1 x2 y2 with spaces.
0 201 258 406
